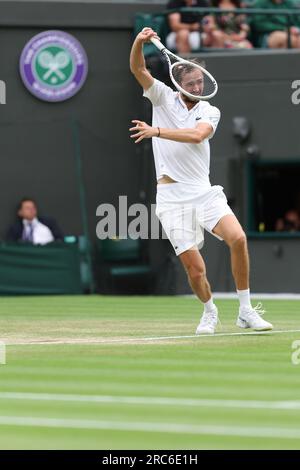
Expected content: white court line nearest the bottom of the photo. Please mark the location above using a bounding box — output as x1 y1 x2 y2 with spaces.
0 416 300 439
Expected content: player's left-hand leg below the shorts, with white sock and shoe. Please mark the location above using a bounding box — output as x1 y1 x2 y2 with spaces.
179 250 218 335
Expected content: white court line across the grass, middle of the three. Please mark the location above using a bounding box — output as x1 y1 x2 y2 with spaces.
0 392 300 410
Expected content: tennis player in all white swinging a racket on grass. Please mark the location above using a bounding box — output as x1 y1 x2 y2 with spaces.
130 28 273 335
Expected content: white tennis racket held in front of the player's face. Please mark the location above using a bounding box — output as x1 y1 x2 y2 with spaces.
150 38 218 101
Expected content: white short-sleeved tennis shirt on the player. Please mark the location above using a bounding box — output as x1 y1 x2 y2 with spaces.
144 79 220 189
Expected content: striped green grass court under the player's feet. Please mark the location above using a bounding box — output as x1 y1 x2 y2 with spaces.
0 296 300 449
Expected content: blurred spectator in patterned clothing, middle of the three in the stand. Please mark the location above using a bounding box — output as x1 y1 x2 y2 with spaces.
202 0 253 49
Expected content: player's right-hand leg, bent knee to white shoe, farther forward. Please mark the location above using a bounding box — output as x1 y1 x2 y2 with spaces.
213 214 273 330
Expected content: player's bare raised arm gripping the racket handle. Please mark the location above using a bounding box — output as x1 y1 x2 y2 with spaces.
130 28 159 90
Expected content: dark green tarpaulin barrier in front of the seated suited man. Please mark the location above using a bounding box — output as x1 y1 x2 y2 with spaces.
0 242 83 295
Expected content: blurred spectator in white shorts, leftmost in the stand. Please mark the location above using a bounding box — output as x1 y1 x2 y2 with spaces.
166 0 208 54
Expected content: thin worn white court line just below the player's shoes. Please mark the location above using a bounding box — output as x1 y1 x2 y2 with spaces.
6 329 300 347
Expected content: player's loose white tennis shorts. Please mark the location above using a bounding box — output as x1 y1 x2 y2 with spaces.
156 183 233 256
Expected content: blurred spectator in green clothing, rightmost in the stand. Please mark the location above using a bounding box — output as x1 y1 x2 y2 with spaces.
252 0 300 49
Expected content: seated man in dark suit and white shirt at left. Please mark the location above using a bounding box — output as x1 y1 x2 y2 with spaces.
6 198 63 245
